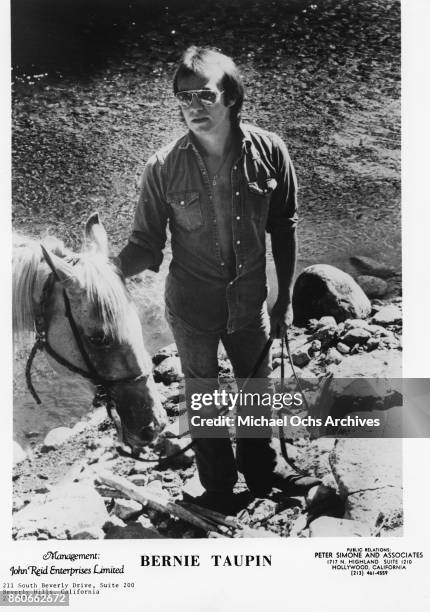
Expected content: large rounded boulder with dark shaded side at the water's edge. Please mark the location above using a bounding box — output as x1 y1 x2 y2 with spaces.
293 264 371 325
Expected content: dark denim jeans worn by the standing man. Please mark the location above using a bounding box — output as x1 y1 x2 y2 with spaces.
166 304 277 493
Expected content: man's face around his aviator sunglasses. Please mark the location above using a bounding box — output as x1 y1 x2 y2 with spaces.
178 74 234 136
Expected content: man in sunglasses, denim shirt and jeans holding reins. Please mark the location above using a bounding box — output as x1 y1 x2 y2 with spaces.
119 47 319 503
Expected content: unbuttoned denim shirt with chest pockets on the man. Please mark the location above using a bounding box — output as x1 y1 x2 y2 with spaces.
130 124 297 333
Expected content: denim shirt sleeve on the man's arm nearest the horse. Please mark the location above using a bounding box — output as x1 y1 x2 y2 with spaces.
129 155 168 272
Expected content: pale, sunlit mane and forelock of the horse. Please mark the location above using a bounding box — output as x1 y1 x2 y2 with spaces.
12 234 130 339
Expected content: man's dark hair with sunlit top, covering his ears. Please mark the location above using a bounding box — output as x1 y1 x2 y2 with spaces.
173 45 245 125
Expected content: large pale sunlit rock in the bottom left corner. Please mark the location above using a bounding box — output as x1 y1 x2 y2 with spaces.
14 483 109 540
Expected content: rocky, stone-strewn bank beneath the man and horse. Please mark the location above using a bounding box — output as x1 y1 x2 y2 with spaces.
13 288 402 539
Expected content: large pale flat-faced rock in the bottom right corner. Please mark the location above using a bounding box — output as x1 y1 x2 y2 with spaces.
329 438 402 528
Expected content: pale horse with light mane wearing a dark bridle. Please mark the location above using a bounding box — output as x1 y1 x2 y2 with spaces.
12 213 167 457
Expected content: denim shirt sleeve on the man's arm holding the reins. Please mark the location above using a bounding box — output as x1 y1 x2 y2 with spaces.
266 136 298 233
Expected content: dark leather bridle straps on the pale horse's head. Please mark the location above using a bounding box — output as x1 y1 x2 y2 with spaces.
25 271 147 429
